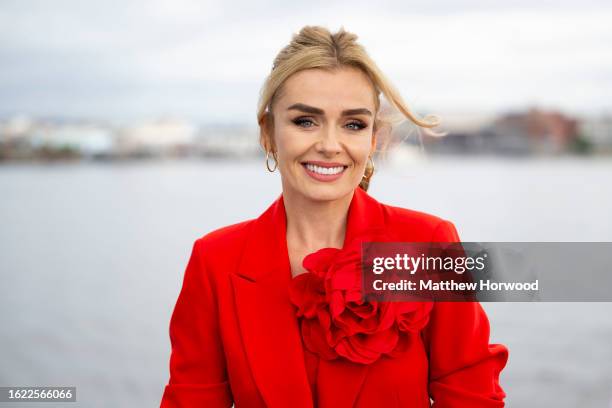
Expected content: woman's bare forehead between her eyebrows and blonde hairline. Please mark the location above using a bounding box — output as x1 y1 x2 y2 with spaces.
277 67 375 112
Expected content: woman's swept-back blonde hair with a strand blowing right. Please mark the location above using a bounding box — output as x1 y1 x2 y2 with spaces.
257 25 439 191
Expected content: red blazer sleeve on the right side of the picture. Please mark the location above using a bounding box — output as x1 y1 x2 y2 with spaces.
422 221 508 408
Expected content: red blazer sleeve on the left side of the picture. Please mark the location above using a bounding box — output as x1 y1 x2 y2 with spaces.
161 238 233 408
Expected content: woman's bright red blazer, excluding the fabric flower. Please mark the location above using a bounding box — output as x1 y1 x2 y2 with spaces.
161 188 508 408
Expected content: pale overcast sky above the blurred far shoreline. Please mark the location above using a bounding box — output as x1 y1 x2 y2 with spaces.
0 0 612 124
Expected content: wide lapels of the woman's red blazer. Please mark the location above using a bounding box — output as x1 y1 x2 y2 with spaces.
231 188 384 408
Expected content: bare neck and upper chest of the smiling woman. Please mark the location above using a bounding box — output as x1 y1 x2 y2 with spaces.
283 188 353 251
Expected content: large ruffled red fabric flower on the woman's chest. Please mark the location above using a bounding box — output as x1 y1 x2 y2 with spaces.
289 234 433 364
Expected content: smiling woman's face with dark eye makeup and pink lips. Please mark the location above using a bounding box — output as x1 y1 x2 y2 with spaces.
272 67 376 201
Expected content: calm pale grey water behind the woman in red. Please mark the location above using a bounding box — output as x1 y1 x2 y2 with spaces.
0 158 612 408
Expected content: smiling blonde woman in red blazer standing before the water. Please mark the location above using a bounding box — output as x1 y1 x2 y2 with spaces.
161 26 508 408
